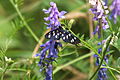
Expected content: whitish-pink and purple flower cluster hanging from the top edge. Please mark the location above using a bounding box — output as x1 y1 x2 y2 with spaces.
89 0 109 37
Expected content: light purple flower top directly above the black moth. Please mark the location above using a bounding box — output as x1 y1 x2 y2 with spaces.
43 2 66 28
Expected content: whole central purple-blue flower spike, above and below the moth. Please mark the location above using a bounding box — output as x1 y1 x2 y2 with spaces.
36 2 66 80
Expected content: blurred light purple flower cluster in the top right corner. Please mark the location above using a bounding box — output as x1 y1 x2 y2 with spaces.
110 0 120 23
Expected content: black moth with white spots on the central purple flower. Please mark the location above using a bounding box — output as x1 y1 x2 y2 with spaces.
45 26 80 44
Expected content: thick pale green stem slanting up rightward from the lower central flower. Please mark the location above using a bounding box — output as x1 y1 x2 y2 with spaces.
53 53 93 74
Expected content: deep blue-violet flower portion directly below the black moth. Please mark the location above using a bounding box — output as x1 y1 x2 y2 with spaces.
36 40 62 80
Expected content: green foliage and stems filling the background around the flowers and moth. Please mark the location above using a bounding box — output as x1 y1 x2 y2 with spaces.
0 0 120 80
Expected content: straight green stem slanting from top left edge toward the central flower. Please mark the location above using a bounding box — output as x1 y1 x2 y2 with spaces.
10 0 39 42
